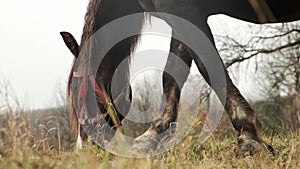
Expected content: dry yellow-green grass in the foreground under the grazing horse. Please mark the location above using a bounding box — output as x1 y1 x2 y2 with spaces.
0 107 300 169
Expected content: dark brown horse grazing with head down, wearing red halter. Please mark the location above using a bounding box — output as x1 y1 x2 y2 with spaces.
61 0 300 153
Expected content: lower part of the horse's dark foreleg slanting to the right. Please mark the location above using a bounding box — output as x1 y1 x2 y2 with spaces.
225 75 275 154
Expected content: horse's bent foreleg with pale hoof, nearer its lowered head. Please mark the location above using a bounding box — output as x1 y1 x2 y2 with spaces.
132 39 192 152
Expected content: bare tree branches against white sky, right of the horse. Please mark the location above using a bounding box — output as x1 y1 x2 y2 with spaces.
216 22 300 97
